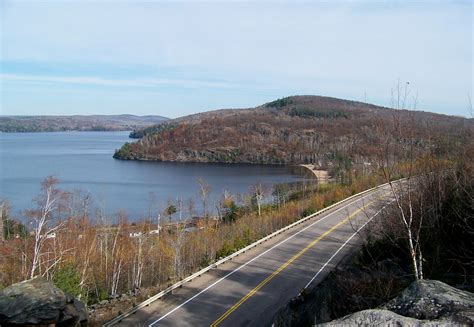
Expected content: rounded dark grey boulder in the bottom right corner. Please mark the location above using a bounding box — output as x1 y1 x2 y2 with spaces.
383 280 474 325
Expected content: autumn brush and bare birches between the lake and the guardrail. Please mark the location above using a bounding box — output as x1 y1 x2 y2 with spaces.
0 176 379 304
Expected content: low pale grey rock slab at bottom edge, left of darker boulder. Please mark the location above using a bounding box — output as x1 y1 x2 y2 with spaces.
317 309 424 327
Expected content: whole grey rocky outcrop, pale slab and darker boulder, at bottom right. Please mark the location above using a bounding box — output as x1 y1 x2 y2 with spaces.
320 280 474 326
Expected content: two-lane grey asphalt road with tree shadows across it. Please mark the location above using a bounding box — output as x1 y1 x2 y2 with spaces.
118 188 390 326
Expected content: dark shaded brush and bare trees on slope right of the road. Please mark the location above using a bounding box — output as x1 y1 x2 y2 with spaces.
275 155 474 326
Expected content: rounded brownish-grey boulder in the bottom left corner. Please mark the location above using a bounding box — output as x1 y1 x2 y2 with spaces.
0 278 87 326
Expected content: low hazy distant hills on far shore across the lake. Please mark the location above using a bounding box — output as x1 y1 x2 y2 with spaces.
0 115 168 133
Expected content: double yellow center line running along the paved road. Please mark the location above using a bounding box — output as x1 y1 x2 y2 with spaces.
210 193 388 327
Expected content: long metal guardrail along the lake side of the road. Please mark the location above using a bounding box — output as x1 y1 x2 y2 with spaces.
102 183 396 327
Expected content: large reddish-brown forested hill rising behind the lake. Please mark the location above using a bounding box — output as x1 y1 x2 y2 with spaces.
114 96 473 166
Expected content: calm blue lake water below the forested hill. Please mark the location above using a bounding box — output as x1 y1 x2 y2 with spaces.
0 132 310 220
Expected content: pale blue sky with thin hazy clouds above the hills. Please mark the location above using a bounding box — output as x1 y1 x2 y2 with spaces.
0 0 474 118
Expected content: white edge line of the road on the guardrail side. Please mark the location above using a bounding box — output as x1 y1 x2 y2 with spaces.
148 186 388 327
